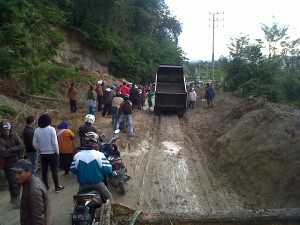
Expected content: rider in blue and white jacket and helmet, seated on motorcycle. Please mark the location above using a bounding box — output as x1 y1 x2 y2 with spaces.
71 132 112 201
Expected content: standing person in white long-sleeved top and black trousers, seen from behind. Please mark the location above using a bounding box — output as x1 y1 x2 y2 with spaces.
32 114 65 193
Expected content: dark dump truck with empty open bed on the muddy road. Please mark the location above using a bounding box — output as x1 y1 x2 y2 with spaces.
154 64 187 118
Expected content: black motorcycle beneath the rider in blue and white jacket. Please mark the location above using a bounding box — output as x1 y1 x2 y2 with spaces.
70 189 112 225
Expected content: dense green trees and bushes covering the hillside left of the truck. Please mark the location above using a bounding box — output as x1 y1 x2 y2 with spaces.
0 0 183 93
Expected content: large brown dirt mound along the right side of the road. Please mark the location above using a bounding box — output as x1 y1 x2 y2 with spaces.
188 94 300 209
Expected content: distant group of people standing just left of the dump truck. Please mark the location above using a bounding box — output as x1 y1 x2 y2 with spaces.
68 80 154 137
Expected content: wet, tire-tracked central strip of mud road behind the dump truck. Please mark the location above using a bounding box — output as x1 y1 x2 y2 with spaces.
117 112 241 213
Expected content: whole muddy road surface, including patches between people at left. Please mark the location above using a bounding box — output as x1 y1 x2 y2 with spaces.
0 95 241 225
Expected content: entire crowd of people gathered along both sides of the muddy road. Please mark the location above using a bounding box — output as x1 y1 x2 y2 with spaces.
0 80 214 225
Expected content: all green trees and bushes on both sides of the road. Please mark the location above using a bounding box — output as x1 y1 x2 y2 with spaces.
0 0 300 105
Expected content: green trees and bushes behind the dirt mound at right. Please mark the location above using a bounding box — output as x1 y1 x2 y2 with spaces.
189 22 300 106
